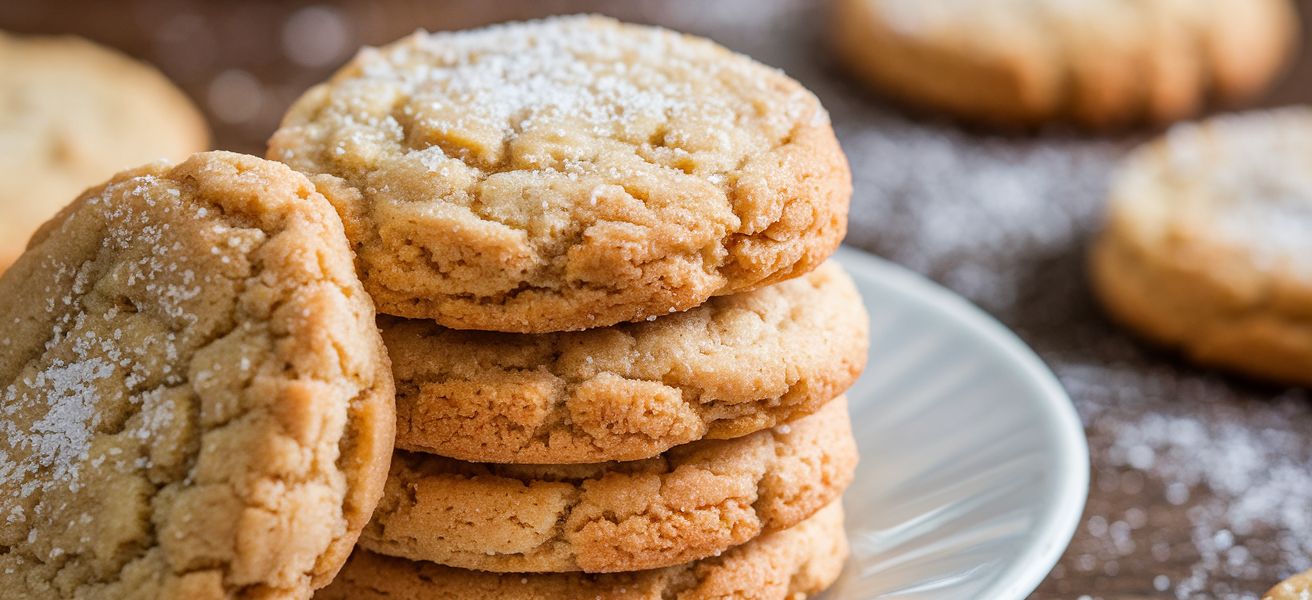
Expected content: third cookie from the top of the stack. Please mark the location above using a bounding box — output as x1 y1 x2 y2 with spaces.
359 398 857 572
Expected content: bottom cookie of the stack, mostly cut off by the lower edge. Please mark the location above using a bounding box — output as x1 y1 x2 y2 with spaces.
315 502 848 600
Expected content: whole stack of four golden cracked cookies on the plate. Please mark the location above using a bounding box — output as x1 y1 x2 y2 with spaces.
269 17 866 600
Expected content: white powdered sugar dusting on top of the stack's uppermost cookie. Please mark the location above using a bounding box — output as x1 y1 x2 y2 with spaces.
348 16 828 156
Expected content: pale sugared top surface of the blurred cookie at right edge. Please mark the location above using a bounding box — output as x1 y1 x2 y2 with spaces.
1106 108 1312 286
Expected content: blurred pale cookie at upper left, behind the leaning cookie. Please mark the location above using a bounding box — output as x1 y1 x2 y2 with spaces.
0 32 210 272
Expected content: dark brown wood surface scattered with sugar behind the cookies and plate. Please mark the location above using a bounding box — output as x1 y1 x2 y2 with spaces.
0 0 1312 600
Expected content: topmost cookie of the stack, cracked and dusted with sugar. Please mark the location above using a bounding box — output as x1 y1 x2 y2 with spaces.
268 16 851 333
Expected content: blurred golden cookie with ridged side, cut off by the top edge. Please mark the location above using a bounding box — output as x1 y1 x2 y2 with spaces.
830 0 1299 127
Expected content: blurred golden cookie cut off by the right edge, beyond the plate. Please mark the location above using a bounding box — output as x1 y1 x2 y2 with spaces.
1092 108 1312 385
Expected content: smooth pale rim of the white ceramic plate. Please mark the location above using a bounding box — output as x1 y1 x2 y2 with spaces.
834 244 1090 600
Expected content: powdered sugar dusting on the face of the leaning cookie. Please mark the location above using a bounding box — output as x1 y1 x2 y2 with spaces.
0 165 264 568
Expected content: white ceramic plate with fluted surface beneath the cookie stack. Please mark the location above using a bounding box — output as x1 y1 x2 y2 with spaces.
824 247 1089 600
